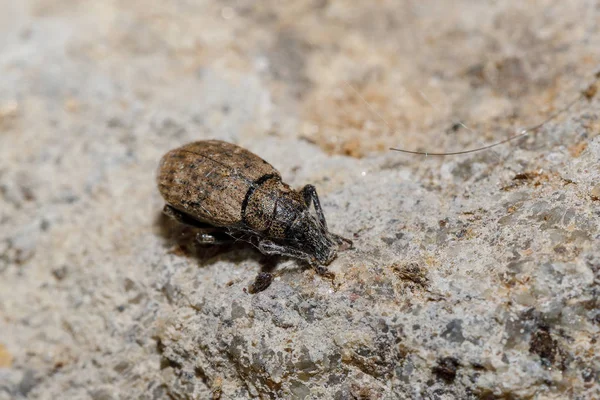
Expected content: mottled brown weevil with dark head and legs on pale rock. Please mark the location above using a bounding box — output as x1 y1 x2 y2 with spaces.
158 140 352 273
